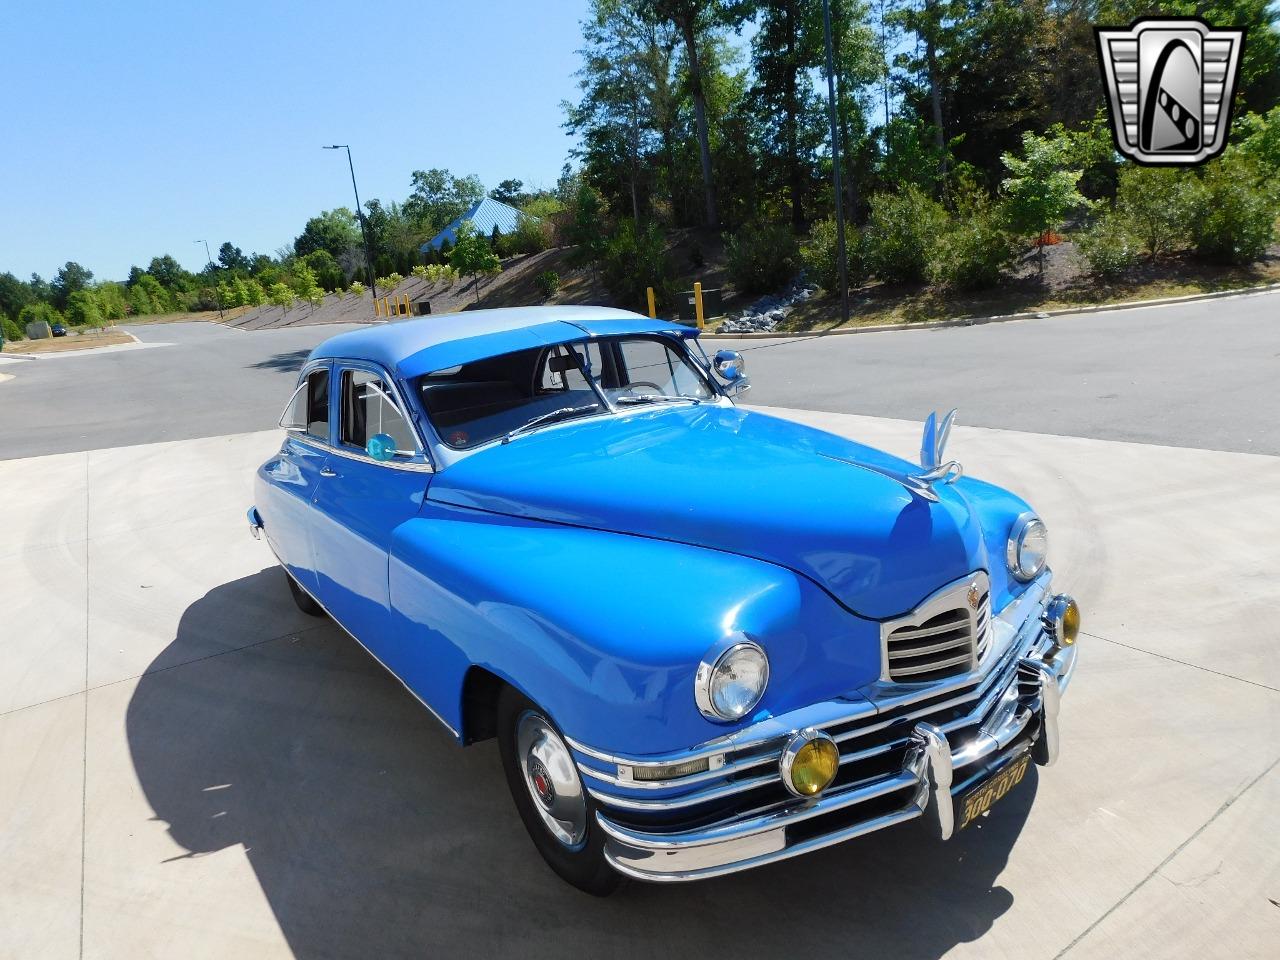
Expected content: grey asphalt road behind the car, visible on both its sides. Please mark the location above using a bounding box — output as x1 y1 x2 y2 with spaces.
0 293 1280 460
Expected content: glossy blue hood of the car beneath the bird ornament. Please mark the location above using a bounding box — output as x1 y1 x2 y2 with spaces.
428 404 987 620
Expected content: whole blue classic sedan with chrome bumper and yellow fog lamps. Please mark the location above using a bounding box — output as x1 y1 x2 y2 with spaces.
248 307 1080 893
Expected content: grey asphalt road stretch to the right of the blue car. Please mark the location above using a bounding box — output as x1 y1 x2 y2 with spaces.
716 293 1280 456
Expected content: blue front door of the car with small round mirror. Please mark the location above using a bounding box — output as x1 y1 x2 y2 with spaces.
311 361 431 663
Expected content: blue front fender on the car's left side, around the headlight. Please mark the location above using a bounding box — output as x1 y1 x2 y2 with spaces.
389 502 879 755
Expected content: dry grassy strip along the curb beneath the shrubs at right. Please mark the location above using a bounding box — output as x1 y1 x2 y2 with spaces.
781 245 1280 333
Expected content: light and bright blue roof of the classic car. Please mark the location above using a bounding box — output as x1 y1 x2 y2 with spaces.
308 306 698 378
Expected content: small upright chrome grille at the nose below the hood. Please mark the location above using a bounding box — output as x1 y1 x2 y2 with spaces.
882 572 991 684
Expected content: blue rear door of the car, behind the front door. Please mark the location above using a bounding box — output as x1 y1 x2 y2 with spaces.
257 361 332 595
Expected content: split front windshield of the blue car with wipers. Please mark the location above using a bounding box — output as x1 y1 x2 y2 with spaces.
417 335 716 449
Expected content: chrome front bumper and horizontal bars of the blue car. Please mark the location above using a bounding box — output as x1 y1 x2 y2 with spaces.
571 573 1075 882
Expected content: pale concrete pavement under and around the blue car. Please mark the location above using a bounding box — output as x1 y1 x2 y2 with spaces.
0 409 1280 960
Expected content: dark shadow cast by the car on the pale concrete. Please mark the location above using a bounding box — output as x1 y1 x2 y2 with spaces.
127 567 1037 959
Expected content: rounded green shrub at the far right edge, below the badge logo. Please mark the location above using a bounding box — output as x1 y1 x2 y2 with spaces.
1192 154 1277 264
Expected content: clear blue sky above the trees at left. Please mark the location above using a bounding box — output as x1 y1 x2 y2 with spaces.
0 0 586 280
